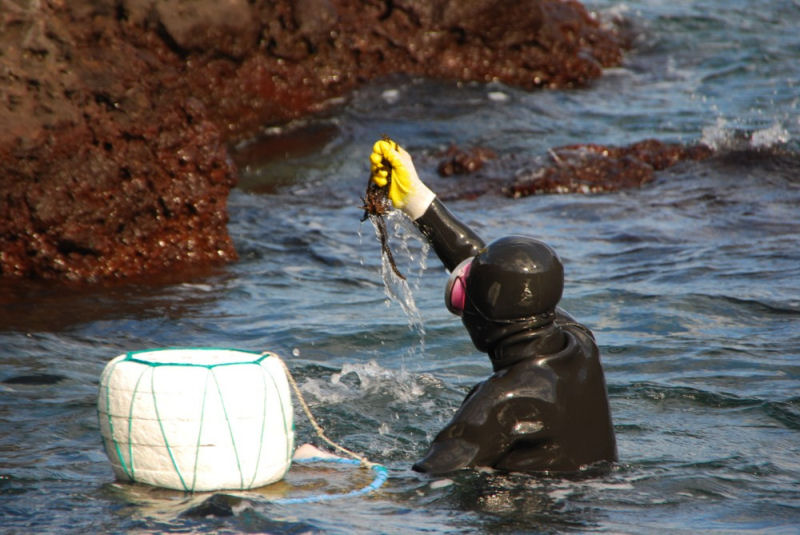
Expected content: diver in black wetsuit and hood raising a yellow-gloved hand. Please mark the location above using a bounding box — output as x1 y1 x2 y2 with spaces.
370 139 617 474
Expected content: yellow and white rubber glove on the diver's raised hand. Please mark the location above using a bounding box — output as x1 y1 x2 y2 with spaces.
369 138 436 219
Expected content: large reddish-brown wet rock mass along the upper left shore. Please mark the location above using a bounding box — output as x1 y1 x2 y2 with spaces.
0 0 622 281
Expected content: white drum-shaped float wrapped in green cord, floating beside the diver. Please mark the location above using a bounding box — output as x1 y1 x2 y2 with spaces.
97 348 294 492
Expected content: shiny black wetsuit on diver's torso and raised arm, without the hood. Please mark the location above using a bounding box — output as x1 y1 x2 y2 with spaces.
413 199 617 474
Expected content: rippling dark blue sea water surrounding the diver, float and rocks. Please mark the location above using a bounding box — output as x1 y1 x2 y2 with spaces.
0 0 800 533
